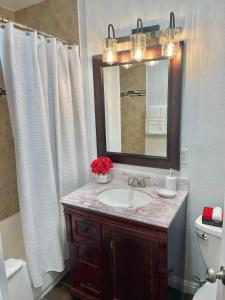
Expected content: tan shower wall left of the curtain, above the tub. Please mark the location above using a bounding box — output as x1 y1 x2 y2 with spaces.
0 7 19 220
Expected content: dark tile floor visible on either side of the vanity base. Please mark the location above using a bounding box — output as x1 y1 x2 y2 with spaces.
46 284 192 300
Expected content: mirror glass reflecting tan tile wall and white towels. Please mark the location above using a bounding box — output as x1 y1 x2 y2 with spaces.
103 59 170 157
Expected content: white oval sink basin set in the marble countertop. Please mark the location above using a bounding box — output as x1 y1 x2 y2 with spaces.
97 188 152 208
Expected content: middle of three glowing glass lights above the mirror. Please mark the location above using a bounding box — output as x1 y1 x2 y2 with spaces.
130 18 146 62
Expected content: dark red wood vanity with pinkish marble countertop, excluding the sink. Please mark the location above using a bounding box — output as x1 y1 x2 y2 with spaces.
62 176 188 300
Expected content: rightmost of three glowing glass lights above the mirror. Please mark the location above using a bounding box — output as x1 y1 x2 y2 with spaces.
161 12 181 58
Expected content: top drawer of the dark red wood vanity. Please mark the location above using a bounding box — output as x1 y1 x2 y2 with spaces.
72 216 101 244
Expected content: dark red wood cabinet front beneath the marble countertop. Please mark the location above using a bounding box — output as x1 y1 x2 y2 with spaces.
64 204 185 300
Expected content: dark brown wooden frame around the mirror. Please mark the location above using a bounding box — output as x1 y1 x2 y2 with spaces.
92 41 184 170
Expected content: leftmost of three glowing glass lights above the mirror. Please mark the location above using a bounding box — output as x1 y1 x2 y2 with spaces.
102 24 117 65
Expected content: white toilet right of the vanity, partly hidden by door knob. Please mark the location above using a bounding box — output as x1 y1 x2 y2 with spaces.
193 216 222 300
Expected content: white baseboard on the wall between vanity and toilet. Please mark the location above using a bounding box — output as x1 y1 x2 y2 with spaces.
168 276 199 295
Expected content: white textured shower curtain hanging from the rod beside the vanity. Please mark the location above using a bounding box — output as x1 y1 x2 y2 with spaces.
0 23 89 287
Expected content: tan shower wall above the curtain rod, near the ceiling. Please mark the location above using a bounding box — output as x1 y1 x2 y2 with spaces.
15 0 79 44
